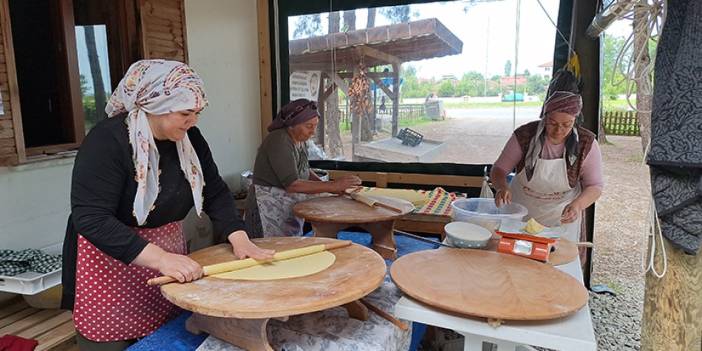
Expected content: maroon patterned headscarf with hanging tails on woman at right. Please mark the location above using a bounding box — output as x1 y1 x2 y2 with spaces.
524 91 583 180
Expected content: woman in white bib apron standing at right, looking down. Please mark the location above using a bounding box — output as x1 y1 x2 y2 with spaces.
491 91 604 241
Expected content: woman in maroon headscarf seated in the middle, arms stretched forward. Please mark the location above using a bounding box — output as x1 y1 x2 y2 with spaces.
246 99 361 237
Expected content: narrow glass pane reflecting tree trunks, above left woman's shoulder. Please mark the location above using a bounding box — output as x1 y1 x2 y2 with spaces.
76 24 112 134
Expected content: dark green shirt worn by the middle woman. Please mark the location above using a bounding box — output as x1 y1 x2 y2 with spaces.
253 128 310 189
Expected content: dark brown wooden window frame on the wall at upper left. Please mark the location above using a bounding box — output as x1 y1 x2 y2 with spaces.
0 0 140 164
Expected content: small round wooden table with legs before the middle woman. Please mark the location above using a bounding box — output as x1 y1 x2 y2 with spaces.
293 196 414 259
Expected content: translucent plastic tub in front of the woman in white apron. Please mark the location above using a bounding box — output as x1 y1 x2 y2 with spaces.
451 197 528 234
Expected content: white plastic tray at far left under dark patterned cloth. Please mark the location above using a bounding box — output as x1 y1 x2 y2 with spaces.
0 243 63 295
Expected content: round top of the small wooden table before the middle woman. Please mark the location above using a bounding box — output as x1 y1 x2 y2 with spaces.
293 195 414 224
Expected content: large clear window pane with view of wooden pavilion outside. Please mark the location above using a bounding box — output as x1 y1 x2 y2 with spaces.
288 0 558 164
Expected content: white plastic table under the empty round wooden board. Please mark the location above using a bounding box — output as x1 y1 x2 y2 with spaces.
395 259 597 351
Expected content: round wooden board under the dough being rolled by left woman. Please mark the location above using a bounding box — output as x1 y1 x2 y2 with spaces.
161 237 386 319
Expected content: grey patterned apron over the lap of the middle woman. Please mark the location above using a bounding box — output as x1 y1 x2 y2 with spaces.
254 185 308 237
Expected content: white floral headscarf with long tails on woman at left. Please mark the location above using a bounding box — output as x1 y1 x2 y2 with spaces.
105 60 207 225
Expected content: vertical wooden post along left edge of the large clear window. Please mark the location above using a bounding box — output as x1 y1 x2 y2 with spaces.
256 0 273 139
